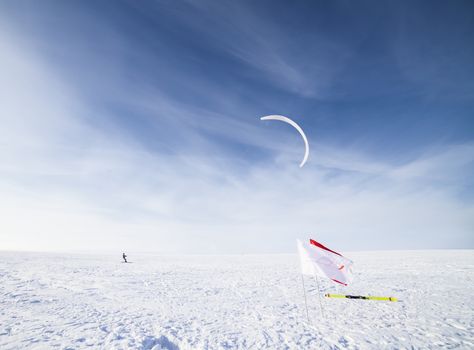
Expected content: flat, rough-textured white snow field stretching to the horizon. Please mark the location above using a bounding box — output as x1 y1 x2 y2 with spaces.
0 250 474 349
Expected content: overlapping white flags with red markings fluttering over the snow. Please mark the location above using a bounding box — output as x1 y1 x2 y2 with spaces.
297 239 353 286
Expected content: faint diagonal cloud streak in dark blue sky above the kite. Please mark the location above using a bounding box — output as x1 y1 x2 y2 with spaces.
153 1 351 98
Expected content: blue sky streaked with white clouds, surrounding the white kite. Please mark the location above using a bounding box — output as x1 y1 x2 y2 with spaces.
0 1 474 253
